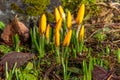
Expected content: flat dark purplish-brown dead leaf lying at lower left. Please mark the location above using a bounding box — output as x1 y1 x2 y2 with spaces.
0 52 35 70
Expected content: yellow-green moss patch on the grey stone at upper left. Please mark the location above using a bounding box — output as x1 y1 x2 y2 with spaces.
11 0 50 16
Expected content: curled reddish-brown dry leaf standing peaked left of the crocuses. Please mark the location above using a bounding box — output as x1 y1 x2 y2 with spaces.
1 16 29 44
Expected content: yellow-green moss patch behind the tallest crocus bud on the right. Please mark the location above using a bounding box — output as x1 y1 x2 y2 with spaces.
61 0 100 17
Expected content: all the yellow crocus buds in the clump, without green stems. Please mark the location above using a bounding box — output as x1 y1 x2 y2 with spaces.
39 4 85 47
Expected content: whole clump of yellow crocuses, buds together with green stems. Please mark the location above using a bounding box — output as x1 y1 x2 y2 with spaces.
35 4 85 80
